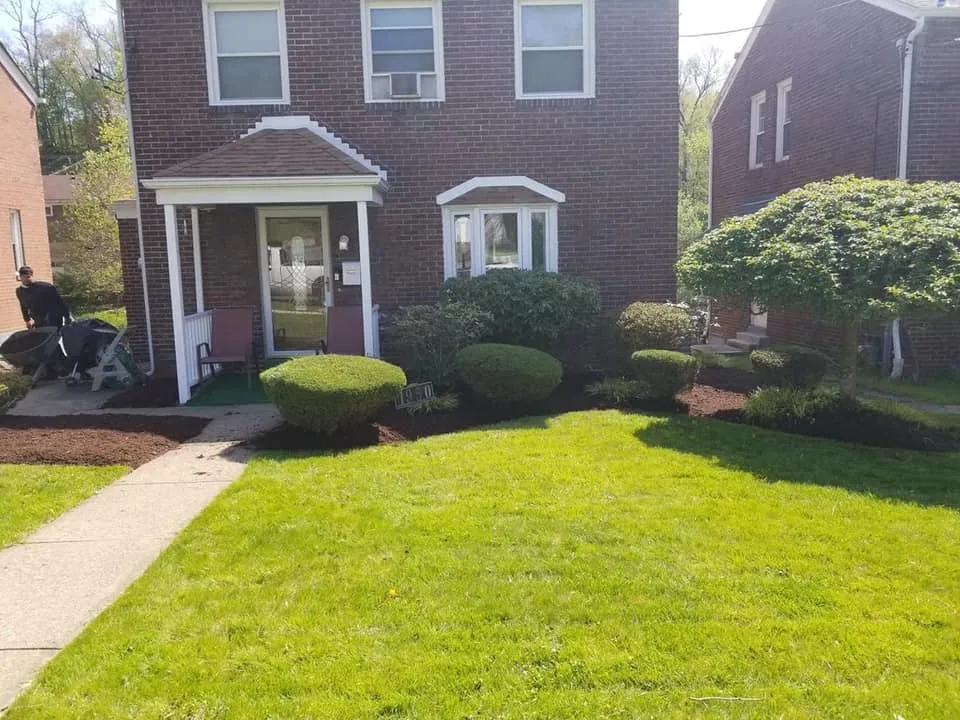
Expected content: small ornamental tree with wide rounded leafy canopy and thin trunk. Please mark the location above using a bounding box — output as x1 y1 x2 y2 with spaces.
677 177 960 394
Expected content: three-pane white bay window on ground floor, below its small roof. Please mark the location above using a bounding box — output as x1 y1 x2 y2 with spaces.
444 205 557 277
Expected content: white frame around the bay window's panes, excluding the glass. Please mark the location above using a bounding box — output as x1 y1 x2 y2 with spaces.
443 203 560 279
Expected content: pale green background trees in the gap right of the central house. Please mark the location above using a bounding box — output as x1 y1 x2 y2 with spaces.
677 48 727 252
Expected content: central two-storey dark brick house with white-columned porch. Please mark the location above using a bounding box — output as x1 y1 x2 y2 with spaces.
120 0 679 399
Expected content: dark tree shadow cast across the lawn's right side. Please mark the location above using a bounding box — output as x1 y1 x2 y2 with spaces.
635 416 960 510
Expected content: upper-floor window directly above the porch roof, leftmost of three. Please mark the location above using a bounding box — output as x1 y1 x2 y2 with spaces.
204 0 290 105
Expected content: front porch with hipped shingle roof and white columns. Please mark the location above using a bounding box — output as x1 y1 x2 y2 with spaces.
144 118 386 403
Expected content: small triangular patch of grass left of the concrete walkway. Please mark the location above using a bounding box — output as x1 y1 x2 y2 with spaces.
0 465 127 547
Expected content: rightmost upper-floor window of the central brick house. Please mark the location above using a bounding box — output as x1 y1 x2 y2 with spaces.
514 0 594 98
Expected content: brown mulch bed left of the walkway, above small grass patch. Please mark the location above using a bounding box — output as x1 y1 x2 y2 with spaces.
0 415 209 467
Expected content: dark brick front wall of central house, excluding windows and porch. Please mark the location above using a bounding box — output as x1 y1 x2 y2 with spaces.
122 0 679 368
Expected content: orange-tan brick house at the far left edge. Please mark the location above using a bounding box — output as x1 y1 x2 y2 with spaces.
0 44 50 337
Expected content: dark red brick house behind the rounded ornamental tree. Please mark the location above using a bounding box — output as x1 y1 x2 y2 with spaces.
710 0 960 371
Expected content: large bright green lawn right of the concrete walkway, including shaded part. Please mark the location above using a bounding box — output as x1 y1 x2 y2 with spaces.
6 411 960 720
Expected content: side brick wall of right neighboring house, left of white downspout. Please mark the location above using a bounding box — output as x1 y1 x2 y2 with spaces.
712 0 912 225
